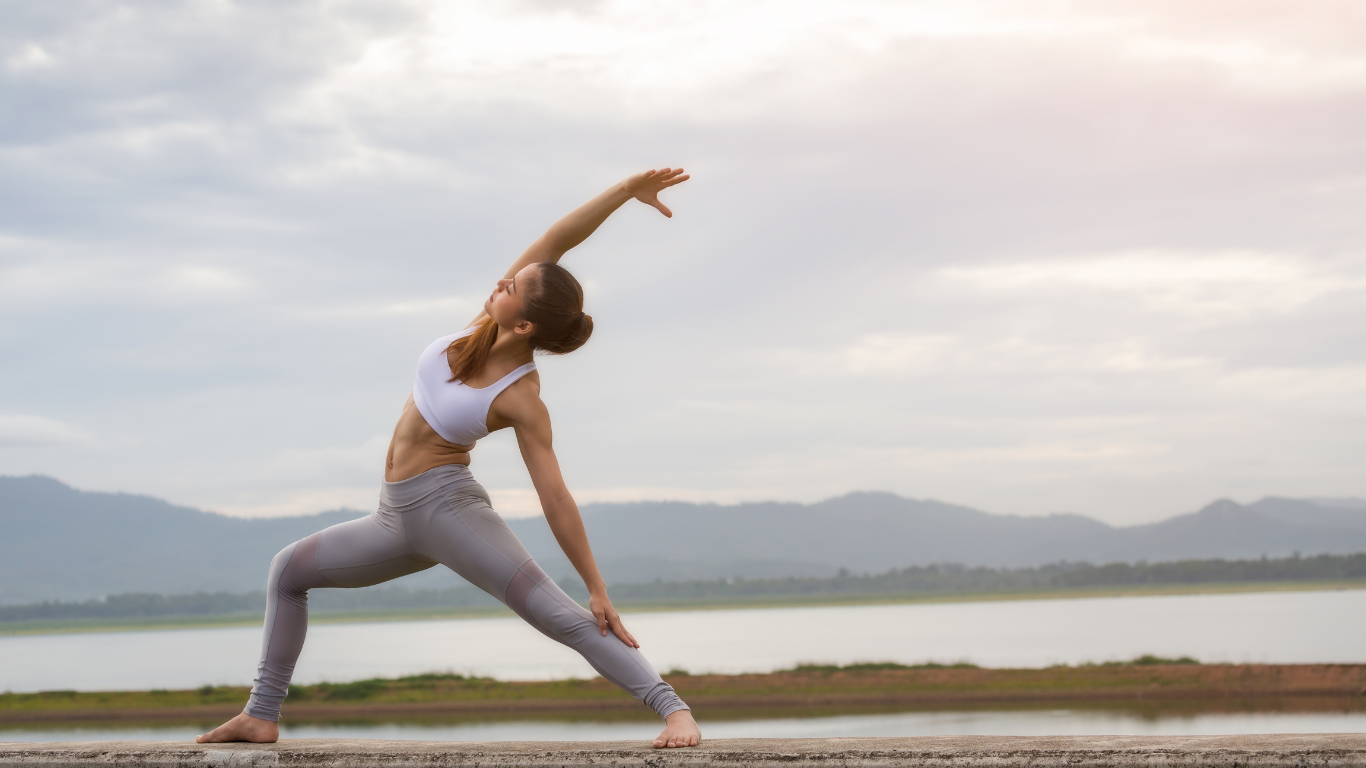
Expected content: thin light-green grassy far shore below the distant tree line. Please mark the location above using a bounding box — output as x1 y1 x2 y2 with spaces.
0 579 1366 635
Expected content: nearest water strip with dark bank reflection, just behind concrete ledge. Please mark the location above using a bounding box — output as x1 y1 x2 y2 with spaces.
0 697 1366 742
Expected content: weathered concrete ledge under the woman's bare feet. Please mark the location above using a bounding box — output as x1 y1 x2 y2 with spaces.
0 734 1366 768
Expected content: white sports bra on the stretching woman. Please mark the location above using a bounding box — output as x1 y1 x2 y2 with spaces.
413 325 535 445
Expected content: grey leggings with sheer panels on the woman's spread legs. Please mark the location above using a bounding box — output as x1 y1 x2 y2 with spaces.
246 465 687 720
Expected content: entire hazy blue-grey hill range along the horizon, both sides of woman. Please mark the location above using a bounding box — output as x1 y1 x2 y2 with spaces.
0 476 1366 604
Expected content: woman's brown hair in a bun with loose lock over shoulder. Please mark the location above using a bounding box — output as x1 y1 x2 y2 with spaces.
445 261 593 381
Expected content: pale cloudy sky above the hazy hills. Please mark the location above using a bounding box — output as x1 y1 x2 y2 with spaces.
0 0 1366 522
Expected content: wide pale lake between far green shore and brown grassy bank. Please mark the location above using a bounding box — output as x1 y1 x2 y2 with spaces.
0 590 1366 694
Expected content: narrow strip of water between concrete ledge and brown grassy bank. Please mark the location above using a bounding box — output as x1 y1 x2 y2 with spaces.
0 709 1366 742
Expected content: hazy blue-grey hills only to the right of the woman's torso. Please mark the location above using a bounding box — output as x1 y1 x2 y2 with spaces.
516 493 1366 582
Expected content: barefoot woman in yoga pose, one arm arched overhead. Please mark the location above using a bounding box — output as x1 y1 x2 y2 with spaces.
195 168 701 748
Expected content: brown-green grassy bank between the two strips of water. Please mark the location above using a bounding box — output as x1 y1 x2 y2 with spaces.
0 657 1366 726
